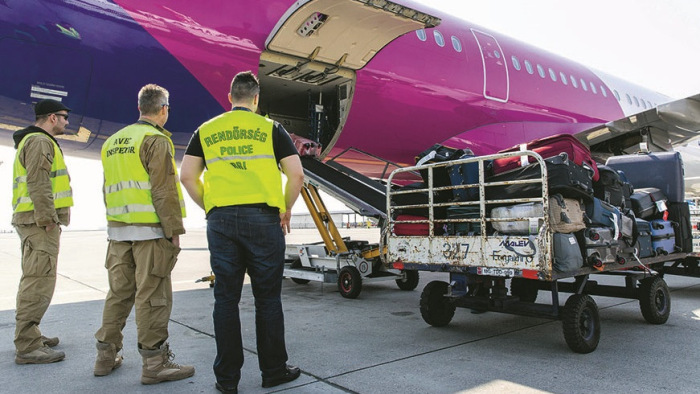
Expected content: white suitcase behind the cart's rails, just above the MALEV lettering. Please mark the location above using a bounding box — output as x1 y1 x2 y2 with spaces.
491 202 544 235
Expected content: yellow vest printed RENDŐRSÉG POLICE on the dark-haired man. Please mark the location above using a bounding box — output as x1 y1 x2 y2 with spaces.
199 110 286 212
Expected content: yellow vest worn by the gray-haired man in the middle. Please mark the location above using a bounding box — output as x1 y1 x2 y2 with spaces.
102 123 185 224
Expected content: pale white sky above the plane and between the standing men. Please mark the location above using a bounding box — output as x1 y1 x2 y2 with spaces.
0 0 700 231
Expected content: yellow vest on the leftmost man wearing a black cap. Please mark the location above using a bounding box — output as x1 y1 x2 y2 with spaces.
12 132 73 212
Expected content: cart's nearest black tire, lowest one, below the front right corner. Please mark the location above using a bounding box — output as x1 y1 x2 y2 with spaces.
562 294 600 354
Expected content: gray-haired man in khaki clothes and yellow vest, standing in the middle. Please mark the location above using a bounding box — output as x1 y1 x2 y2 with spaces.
94 84 194 384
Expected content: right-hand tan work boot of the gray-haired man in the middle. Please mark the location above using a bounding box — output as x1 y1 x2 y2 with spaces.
139 342 194 384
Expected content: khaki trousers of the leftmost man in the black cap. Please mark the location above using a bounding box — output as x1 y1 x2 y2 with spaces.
15 224 61 353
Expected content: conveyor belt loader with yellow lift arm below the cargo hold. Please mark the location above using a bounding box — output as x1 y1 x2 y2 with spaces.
284 158 419 298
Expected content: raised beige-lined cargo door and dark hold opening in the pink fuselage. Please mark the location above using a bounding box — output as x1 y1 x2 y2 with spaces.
258 0 440 157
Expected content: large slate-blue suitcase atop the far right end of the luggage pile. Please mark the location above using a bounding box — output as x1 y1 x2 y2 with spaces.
605 152 685 202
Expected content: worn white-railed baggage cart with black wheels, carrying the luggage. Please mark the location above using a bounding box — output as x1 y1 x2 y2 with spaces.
381 151 686 353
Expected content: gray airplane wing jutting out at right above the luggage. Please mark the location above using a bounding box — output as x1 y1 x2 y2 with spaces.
575 94 700 162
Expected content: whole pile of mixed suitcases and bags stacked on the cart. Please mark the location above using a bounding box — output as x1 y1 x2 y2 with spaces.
393 134 692 272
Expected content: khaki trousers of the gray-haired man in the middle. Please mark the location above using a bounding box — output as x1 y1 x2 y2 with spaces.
95 238 180 350
